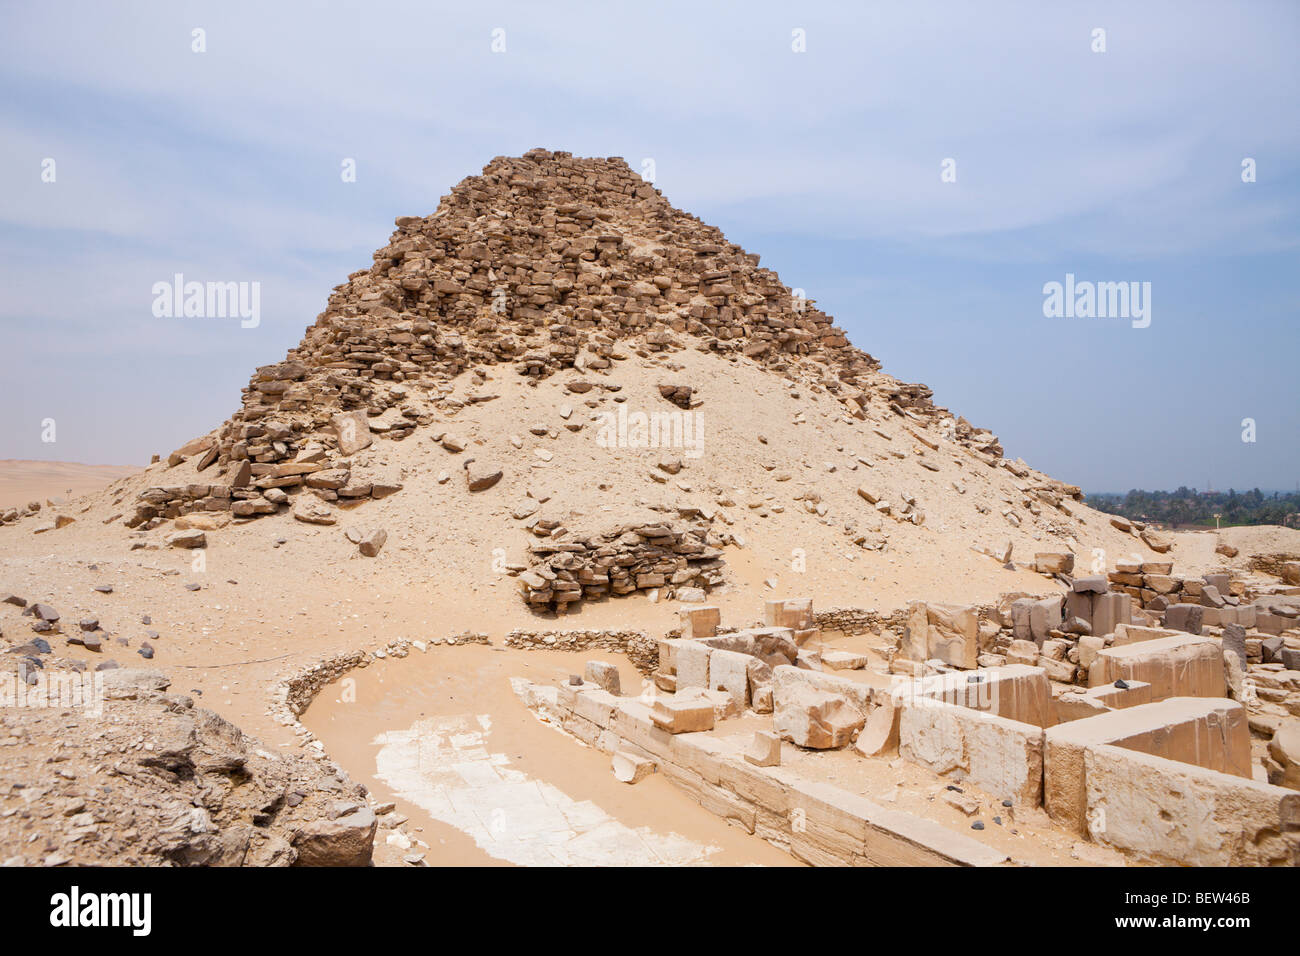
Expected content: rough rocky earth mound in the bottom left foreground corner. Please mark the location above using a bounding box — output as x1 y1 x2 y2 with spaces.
0 661 374 866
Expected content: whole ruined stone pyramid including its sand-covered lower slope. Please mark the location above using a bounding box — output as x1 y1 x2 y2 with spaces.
109 150 1123 607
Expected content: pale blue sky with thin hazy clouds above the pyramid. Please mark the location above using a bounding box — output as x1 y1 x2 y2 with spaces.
0 0 1300 492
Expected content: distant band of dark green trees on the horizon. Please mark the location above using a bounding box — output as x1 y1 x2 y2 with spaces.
1087 488 1300 528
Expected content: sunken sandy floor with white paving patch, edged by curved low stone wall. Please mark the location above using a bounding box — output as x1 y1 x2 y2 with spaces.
304 645 796 866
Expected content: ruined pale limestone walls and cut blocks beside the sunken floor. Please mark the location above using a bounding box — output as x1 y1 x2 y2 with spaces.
514 554 1300 866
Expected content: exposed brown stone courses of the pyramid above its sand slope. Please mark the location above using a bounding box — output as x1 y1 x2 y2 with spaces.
149 150 1003 541
